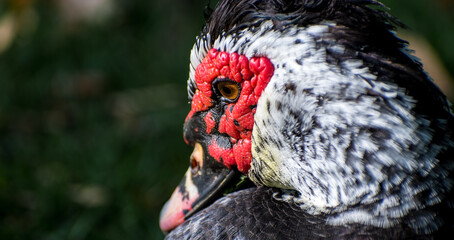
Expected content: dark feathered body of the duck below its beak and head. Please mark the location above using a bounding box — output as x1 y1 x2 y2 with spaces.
166 187 432 240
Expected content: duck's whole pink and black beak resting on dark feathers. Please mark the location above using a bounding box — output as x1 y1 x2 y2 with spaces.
159 143 241 233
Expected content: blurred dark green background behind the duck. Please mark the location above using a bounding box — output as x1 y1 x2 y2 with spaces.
0 0 454 240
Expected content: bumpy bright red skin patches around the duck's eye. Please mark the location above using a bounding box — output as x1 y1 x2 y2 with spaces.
186 49 274 174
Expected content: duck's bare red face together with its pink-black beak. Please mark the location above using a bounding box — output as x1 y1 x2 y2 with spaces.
160 45 274 231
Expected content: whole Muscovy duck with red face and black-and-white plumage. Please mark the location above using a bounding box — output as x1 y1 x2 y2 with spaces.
160 0 454 239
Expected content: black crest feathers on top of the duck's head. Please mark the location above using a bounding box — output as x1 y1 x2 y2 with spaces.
202 0 403 44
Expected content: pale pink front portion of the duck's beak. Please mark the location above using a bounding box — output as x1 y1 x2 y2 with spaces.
159 168 199 233
